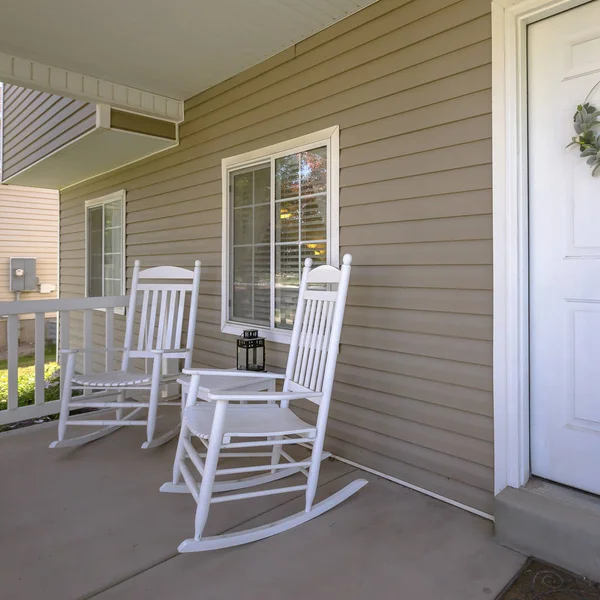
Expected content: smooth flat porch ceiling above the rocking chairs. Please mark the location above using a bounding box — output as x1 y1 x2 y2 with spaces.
0 0 376 100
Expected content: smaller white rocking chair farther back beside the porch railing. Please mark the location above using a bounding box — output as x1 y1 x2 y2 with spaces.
50 260 200 449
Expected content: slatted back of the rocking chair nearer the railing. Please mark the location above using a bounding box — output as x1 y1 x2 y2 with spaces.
121 261 201 370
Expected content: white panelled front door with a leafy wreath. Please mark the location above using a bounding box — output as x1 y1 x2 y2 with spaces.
528 0 600 494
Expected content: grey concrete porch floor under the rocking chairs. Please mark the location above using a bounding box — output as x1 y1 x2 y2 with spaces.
0 423 525 600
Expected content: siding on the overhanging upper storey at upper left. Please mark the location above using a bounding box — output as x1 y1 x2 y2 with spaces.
2 85 96 180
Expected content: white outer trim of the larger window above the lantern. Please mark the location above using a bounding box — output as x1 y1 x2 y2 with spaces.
223 125 340 344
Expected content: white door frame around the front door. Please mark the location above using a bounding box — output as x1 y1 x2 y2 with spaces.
492 0 592 494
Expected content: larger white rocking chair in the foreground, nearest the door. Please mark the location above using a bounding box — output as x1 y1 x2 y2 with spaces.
161 254 367 552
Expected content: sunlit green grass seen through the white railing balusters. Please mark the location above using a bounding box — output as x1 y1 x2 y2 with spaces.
0 346 60 410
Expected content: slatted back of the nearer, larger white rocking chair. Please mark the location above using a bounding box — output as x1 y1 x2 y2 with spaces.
284 254 352 403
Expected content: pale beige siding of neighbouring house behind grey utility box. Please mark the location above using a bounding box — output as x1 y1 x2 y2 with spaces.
0 185 58 302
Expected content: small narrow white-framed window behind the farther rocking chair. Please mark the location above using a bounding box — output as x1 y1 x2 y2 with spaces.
85 190 125 297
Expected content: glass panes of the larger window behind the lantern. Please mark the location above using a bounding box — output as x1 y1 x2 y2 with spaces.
229 146 328 329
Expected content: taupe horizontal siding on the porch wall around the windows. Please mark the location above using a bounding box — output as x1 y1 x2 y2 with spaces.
61 0 493 513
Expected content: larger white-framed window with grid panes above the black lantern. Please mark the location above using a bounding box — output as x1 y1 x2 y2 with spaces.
222 127 339 342
